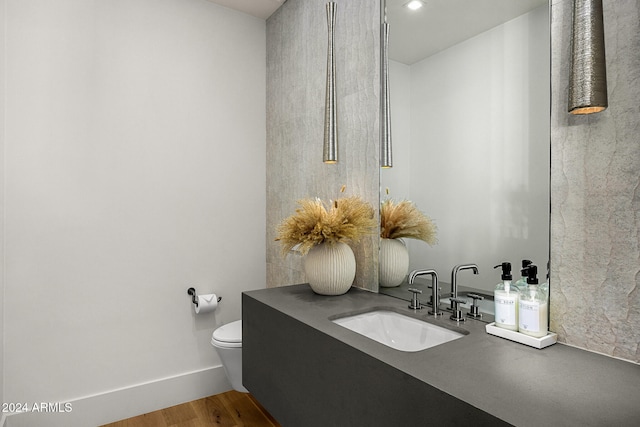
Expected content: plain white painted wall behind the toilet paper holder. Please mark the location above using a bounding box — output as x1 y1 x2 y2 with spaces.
3 0 266 422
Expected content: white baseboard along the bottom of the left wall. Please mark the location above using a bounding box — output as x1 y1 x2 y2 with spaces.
5 366 231 427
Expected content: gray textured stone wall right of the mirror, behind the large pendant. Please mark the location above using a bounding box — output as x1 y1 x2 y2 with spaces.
551 0 640 363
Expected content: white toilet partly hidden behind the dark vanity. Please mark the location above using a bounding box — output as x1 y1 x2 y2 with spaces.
211 320 249 393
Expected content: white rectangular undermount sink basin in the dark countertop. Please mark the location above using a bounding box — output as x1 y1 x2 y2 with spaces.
332 310 464 351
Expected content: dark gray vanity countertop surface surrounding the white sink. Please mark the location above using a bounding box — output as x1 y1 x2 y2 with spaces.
246 284 640 427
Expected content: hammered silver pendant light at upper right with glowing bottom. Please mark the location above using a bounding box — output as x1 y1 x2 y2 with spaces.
568 0 608 114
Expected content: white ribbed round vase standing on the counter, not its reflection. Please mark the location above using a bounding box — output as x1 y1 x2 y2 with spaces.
303 242 356 295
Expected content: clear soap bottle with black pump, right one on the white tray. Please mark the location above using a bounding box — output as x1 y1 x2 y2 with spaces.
518 264 549 338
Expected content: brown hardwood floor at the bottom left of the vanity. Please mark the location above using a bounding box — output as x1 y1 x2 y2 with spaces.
101 390 280 427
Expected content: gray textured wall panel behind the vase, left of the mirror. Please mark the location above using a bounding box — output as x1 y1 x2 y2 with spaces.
266 0 380 291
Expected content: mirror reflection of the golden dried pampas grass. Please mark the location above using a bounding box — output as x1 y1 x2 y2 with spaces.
380 199 438 246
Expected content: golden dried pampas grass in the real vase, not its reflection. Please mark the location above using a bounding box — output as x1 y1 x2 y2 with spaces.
276 190 377 256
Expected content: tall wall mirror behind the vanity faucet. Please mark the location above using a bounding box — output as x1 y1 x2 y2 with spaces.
380 0 550 299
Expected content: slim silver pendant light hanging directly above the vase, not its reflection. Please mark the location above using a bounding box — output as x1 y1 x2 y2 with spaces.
322 2 338 163
